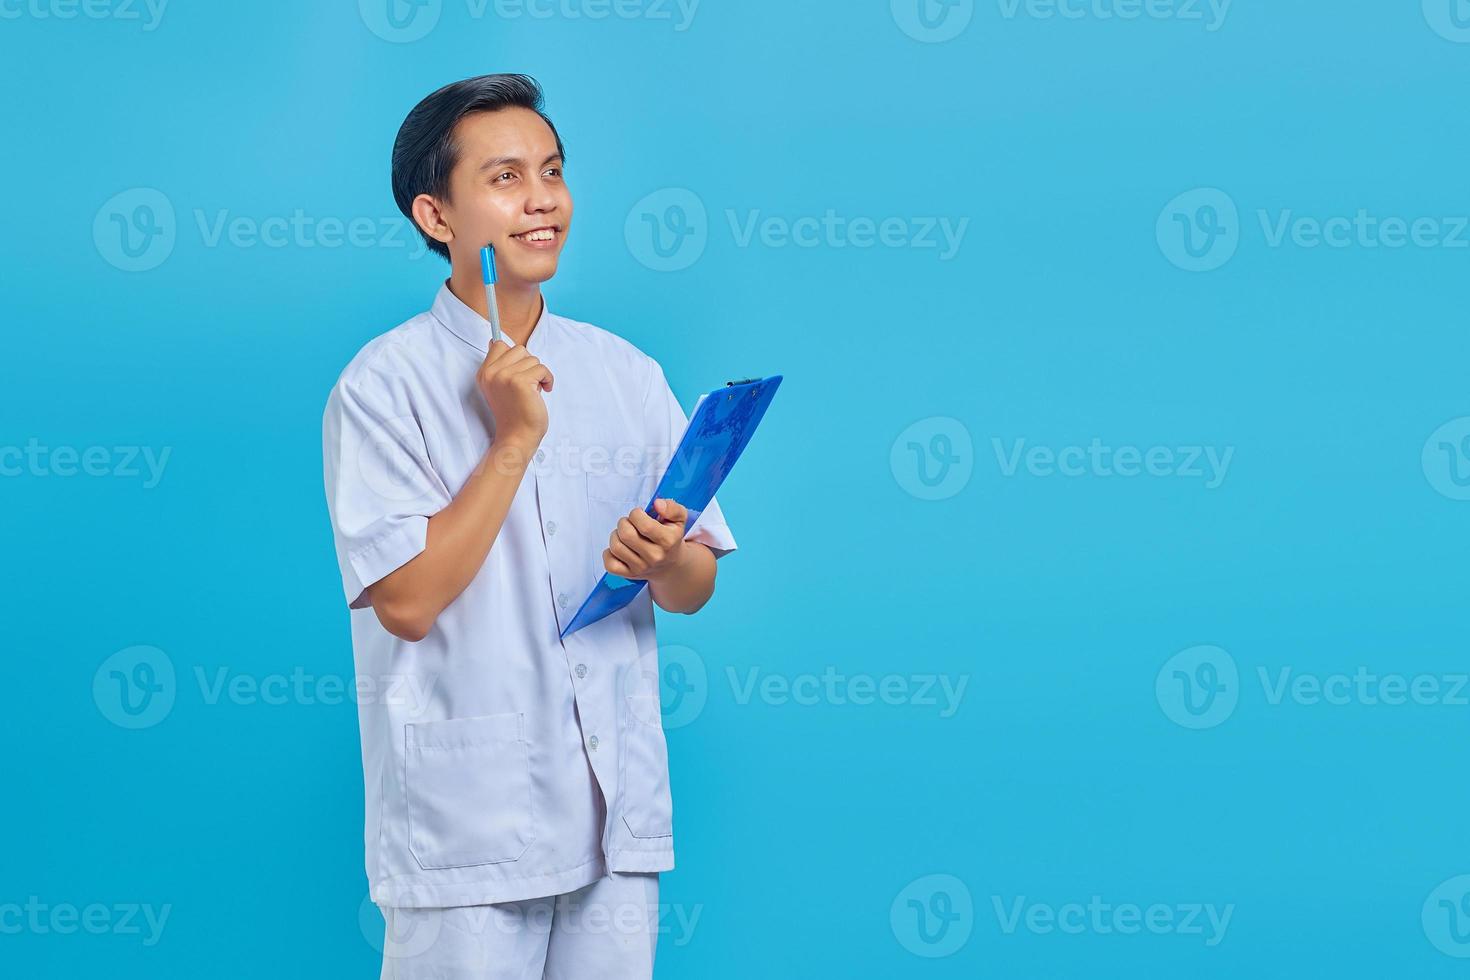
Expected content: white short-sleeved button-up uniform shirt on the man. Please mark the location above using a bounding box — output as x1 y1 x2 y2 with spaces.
322 284 735 907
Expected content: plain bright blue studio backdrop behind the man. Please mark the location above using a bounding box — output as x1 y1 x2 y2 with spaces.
0 0 1470 979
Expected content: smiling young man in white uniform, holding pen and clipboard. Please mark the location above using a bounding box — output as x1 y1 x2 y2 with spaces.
322 75 735 980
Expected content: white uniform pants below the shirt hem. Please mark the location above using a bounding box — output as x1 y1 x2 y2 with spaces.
382 874 659 980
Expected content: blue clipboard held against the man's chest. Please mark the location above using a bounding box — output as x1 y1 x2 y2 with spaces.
562 375 781 639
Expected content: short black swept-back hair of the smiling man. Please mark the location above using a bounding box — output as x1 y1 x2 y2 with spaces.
392 75 566 262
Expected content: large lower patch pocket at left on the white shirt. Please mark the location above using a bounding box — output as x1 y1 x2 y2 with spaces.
403 713 537 868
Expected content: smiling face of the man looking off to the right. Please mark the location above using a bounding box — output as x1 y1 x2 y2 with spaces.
441 109 572 282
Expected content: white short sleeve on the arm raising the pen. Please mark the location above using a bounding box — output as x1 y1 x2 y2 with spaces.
322 378 450 610
